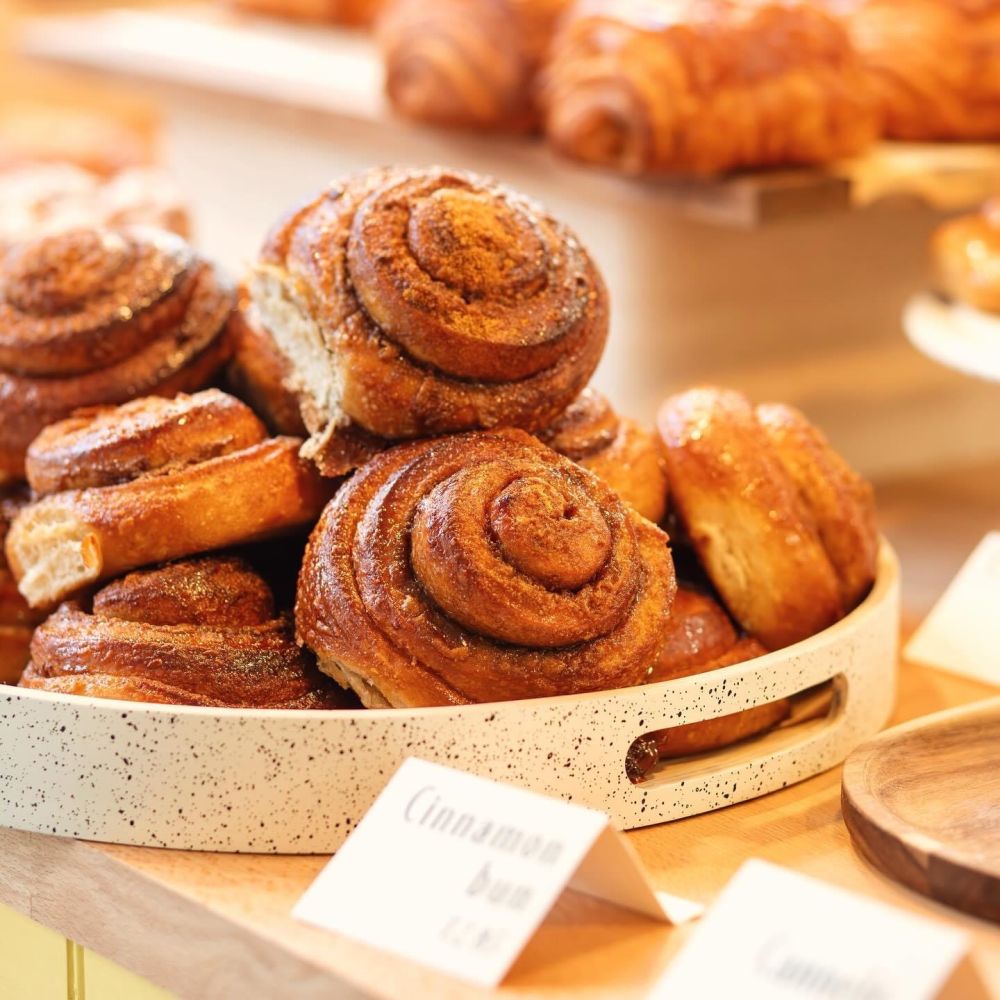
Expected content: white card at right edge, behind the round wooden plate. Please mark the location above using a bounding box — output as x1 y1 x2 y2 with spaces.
906 531 1000 685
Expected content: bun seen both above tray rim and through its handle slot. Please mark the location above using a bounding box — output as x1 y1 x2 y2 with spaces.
625 585 791 781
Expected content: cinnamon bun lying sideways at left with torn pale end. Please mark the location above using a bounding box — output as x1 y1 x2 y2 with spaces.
6 389 333 607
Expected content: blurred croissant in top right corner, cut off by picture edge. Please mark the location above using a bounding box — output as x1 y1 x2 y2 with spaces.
831 0 1000 140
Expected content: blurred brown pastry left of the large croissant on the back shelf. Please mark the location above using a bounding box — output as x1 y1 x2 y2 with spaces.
377 0 569 131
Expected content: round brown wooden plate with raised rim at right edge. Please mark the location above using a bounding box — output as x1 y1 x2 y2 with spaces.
841 698 1000 923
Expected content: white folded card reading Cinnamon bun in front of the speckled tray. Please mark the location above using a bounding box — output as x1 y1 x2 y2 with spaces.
293 758 701 986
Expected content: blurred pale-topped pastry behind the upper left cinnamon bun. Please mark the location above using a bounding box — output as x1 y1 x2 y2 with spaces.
0 163 191 247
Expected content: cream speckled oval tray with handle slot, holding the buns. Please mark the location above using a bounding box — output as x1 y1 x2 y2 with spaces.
0 545 899 854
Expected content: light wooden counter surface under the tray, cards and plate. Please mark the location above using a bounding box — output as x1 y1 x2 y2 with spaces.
0 465 1000 1000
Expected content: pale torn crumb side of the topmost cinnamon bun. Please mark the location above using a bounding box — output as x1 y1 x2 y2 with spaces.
250 265 348 434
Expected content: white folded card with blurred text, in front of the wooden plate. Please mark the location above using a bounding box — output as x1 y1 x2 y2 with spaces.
650 860 988 1000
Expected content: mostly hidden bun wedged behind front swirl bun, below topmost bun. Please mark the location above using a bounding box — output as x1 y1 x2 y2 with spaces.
538 387 668 524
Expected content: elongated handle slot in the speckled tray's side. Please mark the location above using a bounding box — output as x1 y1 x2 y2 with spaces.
625 674 847 789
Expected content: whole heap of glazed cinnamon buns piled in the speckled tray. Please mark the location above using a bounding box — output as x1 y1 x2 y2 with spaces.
0 169 876 776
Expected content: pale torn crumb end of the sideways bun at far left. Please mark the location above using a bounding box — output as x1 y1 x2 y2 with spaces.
7 507 103 608
